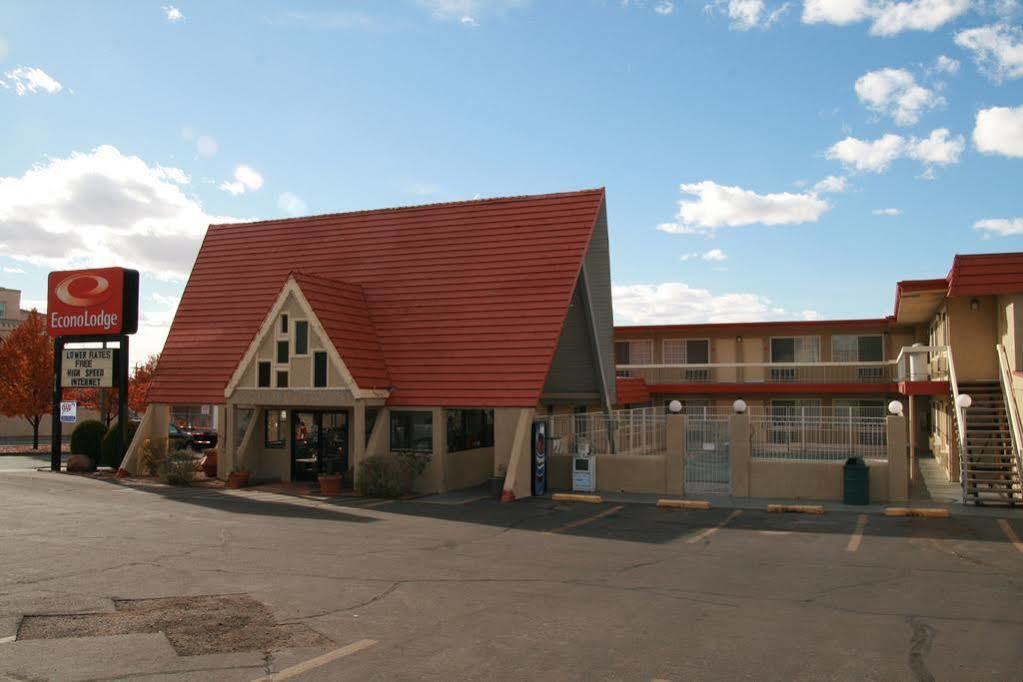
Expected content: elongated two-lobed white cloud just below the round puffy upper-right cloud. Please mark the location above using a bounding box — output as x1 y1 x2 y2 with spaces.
826 128 966 173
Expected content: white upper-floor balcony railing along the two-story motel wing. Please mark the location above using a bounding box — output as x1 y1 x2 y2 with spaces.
617 346 947 384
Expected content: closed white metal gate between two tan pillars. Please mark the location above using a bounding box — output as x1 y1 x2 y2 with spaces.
684 414 731 495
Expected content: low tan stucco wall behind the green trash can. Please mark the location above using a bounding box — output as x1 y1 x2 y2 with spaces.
750 459 888 502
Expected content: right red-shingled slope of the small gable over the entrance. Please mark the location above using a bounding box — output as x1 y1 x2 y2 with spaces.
292 272 391 389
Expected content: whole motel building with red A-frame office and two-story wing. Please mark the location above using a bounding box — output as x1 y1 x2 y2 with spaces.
123 189 1023 504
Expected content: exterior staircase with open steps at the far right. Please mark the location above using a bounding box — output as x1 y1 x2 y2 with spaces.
959 381 1023 505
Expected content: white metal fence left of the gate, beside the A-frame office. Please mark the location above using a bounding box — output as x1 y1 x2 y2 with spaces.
536 407 667 455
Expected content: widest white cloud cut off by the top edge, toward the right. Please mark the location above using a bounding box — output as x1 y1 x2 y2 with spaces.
803 0 970 36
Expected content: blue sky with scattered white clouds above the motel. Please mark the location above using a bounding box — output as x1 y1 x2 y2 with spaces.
0 0 1023 361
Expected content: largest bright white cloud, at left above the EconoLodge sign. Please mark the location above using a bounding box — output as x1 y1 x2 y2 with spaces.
0 145 233 280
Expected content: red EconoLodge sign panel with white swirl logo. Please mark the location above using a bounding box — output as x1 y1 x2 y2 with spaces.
46 268 138 336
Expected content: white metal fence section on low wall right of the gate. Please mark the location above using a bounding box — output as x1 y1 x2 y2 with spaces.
750 407 888 461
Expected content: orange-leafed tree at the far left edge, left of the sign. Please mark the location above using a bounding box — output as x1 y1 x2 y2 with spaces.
0 310 53 450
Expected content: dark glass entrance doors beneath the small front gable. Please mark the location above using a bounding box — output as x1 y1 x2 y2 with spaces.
292 411 349 481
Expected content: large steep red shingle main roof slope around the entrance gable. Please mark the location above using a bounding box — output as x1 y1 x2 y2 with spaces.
149 188 604 407
